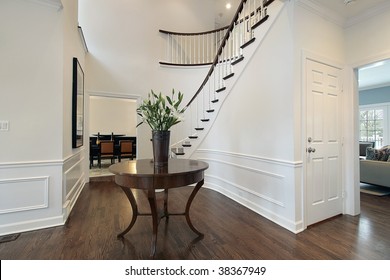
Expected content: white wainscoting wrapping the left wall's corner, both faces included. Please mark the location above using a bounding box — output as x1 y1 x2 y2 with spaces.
0 148 87 236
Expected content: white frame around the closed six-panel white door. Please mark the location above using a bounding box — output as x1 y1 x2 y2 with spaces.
301 50 346 229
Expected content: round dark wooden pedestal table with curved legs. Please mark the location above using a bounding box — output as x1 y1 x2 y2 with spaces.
109 159 209 257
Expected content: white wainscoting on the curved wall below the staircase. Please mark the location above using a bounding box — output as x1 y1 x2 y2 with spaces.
193 149 303 232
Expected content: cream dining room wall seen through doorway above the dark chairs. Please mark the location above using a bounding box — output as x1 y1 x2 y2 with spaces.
89 96 137 136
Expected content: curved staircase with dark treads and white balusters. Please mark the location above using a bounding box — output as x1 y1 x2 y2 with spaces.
160 0 284 158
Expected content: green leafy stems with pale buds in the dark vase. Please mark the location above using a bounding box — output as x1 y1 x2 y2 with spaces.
137 89 186 131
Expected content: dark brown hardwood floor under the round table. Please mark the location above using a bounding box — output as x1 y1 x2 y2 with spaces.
0 181 390 260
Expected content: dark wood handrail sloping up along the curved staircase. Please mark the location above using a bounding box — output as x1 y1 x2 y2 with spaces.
186 0 274 108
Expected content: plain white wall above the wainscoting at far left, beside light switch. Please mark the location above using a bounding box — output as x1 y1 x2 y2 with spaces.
0 0 63 163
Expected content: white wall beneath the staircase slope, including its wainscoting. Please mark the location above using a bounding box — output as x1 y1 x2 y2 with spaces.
193 2 302 232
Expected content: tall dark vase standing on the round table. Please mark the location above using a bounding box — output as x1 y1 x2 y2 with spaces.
152 131 171 166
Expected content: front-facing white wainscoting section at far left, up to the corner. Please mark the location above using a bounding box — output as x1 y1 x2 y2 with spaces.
0 161 64 235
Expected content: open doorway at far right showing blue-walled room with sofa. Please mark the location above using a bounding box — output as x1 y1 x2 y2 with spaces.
356 59 390 196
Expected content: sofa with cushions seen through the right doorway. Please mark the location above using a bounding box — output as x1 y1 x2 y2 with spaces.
360 146 390 188
